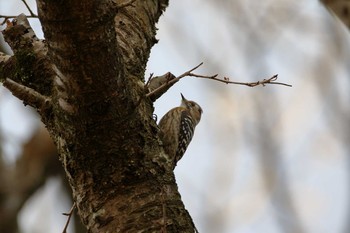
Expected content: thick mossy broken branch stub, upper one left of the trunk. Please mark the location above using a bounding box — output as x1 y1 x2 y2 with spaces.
0 14 55 101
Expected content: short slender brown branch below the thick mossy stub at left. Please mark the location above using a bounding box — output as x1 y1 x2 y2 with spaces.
3 78 51 112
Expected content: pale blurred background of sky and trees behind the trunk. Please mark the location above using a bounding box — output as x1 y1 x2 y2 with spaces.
0 0 350 233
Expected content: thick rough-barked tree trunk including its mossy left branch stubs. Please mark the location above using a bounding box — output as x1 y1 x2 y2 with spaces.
0 0 195 232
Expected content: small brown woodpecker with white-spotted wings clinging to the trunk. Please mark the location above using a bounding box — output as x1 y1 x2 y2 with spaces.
158 94 203 168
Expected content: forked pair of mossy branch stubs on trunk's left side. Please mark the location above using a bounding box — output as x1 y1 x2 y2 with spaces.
0 12 55 117
